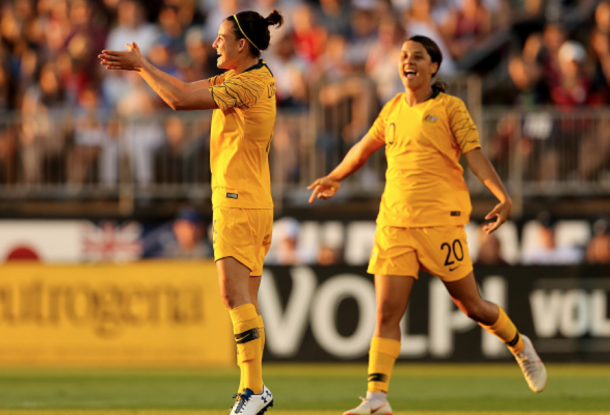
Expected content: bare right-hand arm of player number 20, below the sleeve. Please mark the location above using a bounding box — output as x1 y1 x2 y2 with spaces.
465 148 513 234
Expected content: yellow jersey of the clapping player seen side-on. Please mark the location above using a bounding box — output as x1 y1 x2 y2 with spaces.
208 60 276 209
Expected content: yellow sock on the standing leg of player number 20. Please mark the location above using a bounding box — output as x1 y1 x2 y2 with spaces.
367 337 400 393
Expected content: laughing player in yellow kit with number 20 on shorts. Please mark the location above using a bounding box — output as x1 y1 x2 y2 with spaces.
308 36 546 415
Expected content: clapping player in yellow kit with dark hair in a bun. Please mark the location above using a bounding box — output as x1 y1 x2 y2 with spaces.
99 10 283 415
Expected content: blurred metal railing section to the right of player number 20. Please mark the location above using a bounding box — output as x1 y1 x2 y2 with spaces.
468 108 610 197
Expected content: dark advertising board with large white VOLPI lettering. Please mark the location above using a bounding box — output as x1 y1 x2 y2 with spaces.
260 266 610 362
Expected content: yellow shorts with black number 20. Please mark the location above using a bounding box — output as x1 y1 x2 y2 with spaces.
367 225 472 281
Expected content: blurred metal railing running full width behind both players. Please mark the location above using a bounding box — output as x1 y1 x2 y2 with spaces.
0 103 610 216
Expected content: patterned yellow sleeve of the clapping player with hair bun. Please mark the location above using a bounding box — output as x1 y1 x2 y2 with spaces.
208 73 266 111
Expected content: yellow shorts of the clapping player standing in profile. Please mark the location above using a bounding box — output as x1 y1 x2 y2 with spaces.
212 208 273 277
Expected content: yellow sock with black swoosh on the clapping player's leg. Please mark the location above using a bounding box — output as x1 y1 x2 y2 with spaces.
230 304 263 395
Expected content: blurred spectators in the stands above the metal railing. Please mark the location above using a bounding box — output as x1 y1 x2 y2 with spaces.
0 0 610 114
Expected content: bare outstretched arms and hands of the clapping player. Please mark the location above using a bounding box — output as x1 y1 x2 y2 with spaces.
98 42 218 110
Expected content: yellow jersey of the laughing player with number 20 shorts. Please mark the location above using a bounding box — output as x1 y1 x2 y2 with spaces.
369 91 481 227
